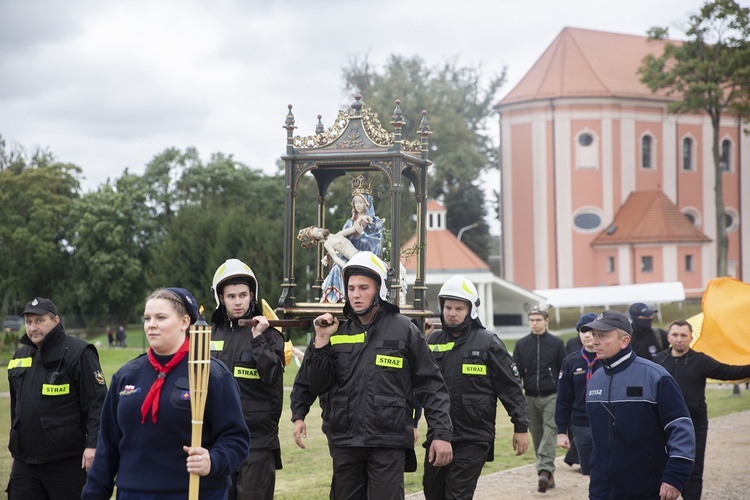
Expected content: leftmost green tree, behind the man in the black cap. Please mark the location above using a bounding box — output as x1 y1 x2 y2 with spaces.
0 149 81 312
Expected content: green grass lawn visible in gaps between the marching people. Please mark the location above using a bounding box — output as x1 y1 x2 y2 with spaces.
0 328 750 500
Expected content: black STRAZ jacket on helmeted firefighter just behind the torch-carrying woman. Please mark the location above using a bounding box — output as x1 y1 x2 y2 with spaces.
211 305 284 454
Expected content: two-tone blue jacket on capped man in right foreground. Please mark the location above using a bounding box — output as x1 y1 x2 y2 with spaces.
586 346 695 499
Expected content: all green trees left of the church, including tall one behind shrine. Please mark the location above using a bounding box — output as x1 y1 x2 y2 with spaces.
0 56 504 328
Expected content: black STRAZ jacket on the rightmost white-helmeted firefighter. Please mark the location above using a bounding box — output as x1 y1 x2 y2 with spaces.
427 321 529 443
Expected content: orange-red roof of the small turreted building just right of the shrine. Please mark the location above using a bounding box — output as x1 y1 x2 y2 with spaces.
402 229 490 272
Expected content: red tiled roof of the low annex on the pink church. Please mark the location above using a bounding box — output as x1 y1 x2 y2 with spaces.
591 190 711 246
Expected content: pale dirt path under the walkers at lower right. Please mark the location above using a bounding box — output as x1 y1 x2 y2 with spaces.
406 410 750 500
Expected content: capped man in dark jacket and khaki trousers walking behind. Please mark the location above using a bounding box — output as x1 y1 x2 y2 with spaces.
513 307 565 493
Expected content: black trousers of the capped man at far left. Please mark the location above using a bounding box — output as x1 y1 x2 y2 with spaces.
8 453 86 500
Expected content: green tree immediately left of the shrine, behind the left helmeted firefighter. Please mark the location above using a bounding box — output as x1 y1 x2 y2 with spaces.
148 149 284 311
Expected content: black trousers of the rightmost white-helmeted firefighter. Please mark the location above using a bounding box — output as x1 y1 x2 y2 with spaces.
422 443 490 500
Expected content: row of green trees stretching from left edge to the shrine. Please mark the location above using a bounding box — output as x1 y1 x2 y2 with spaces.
0 148 314 328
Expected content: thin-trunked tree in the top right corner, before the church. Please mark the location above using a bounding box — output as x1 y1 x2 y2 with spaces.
639 0 750 276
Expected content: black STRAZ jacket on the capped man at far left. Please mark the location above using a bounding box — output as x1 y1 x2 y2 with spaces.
8 323 107 464
